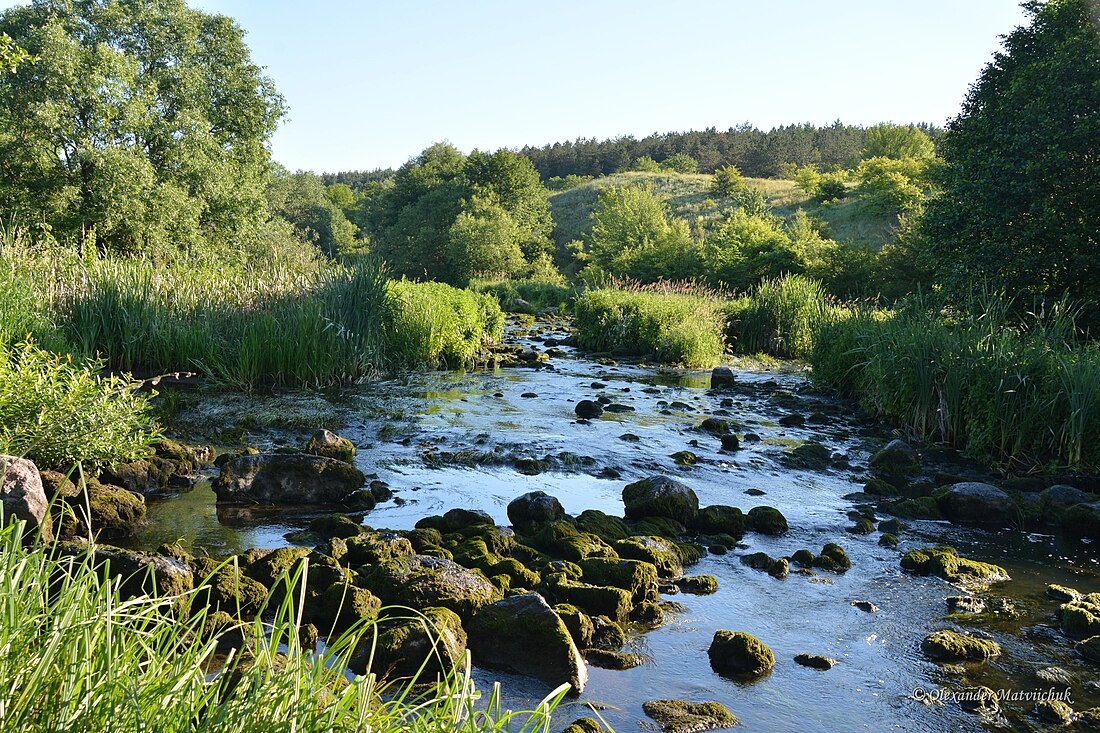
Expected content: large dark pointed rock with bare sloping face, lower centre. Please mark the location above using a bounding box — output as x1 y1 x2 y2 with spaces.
469 593 589 694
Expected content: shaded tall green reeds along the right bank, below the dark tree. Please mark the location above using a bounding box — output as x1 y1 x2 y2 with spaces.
811 293 1100 470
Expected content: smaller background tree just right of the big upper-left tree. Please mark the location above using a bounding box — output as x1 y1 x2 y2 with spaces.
266 168 359 256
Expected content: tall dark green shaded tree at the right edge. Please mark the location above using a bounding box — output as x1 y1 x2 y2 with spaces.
924 0 1100 312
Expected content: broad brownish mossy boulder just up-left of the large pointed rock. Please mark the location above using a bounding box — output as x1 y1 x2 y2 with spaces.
360 555 501 619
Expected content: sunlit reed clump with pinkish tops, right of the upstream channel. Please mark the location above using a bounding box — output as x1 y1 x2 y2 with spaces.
573 285 725 369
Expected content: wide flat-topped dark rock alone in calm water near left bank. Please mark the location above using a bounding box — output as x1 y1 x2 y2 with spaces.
213 453 366 504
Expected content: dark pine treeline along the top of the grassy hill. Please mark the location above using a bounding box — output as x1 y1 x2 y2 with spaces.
519 120 942 180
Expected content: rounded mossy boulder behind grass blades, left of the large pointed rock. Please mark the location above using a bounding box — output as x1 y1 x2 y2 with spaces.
348 608 466 682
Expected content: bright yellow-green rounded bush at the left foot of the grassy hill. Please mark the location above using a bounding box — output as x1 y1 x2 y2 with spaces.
587 185 699 283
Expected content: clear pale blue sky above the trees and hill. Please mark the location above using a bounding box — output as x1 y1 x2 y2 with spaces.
0 0 1025 172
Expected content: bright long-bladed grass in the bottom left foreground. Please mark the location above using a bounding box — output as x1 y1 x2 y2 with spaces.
0 525 564 733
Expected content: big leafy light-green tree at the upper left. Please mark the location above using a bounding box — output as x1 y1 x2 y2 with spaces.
0 0 284 251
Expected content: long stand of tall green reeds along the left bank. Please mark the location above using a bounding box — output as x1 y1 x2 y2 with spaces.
0 241 503 389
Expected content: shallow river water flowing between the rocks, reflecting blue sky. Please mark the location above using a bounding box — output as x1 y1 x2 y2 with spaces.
138 316 1100 733
